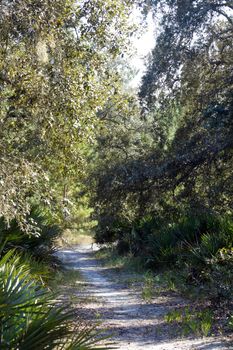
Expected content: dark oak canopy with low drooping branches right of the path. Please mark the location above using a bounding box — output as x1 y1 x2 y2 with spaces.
92 0 233 241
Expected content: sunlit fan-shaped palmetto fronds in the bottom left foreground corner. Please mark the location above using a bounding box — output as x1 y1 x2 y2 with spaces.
0 251 112 350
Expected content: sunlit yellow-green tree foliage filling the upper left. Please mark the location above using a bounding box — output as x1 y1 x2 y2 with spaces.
0 0 133 228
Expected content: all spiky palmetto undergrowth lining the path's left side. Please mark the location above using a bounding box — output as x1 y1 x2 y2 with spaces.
0 208 112 350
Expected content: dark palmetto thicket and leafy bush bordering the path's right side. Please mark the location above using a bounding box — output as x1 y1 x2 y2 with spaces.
102 215 233 302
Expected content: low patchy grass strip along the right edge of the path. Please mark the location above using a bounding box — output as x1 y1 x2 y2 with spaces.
93 247 233 336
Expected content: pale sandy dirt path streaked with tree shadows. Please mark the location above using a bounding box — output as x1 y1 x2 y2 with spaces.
59 245 233 350
